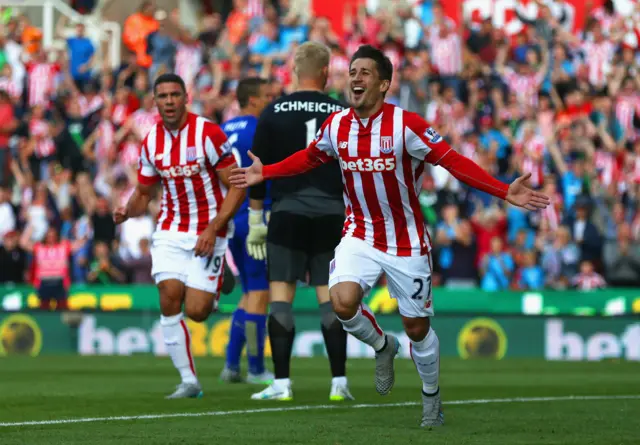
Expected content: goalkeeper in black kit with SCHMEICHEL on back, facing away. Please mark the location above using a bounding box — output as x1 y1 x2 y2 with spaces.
247 42 352 401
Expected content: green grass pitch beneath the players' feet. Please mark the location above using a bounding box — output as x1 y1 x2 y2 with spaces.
0 356 640 445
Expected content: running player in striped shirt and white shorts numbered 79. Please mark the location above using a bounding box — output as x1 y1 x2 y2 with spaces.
114 74 245 398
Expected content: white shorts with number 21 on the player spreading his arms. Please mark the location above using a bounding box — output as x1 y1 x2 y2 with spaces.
329 237 433 318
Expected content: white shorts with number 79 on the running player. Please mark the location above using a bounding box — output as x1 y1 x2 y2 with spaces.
151 232 228 294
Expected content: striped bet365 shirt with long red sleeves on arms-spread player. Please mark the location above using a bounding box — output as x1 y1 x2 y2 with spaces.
262 103 508 256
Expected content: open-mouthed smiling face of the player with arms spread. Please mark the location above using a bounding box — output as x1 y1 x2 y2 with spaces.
349 58 391 117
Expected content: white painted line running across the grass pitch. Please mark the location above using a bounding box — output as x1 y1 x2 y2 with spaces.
0 394 640 427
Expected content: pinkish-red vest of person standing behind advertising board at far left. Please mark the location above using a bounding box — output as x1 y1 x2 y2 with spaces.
33 240 71 287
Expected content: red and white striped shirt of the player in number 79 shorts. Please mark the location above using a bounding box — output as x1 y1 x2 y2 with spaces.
138 113 235 241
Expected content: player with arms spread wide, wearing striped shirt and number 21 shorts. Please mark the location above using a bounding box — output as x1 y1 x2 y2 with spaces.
231 46 549 427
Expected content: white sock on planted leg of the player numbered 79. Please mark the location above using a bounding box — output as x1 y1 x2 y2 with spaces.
160 313 198 383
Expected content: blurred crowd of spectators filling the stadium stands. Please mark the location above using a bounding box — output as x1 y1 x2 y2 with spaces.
0 0 640 290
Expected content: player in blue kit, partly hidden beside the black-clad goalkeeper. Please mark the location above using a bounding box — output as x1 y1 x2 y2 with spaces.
220 77 273 384
